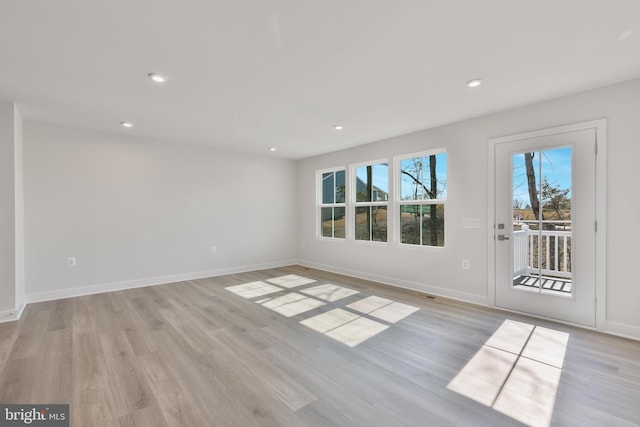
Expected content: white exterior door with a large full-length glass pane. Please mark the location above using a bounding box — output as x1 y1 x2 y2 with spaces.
493 128 596 326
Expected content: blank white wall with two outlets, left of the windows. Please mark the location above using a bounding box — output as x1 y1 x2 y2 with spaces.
24 121 297 301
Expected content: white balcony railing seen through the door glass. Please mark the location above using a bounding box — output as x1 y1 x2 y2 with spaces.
512 224 571 279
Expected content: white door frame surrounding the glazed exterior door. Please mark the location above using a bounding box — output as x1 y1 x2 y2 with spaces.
487 119 607 331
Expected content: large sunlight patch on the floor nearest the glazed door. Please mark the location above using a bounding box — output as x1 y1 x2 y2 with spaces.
447 319 569 427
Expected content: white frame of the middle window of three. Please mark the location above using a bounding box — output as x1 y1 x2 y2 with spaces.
347 159 393 245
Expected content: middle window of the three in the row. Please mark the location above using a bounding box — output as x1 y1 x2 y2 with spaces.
352 163 389 242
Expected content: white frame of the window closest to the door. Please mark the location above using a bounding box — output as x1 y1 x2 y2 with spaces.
393 147 449 251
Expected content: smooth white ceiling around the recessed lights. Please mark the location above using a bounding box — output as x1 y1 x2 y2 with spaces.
0 0 640 159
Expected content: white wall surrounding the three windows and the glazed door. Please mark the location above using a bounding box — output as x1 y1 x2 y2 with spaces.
298 80 640 338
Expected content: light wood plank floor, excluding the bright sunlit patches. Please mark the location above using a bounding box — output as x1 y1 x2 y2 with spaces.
0 267 640 427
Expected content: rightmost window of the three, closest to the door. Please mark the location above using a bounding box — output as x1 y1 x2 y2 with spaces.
398 150 447 246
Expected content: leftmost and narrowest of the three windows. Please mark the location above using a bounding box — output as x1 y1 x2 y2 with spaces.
318 169 346 239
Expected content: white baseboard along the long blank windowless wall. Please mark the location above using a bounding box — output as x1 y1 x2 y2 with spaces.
26 260 297 306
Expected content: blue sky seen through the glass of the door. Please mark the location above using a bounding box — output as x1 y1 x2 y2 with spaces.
513 147 572 206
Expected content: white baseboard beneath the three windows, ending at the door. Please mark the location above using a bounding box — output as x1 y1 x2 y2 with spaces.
298 260 488 307
